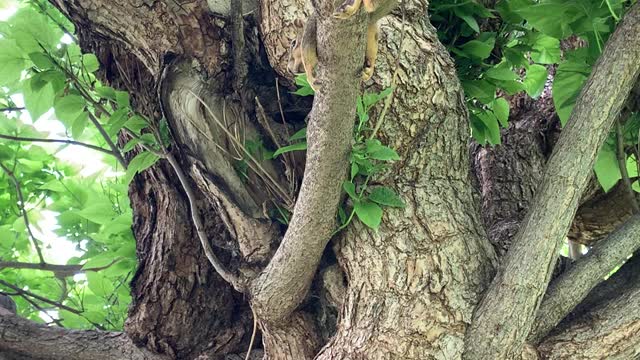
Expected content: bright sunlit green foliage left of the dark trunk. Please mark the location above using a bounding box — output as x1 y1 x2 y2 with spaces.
0 0 160 330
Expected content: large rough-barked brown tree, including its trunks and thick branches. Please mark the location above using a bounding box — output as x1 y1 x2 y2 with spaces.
0 0 640 360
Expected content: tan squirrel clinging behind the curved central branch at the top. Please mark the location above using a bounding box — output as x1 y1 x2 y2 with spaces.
287 0 398 89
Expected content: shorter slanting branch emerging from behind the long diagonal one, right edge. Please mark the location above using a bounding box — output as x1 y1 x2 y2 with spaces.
529 215 640 343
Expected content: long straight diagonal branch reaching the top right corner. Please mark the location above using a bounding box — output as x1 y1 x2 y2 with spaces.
464 4 640 360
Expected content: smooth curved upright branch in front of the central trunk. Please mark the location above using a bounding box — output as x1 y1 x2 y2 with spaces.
252 1 365 322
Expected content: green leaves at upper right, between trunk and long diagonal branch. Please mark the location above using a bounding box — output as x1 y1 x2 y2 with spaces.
430 0 640 190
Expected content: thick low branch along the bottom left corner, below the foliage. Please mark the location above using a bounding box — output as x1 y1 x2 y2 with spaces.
0 310 168 360
